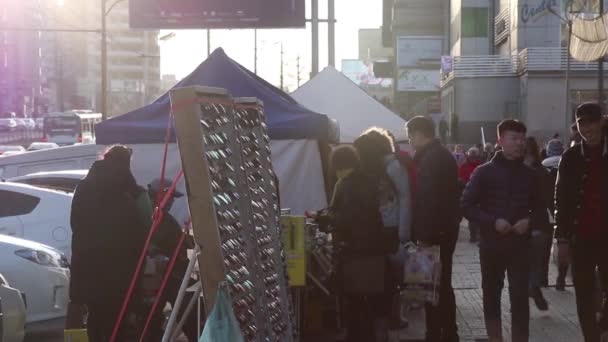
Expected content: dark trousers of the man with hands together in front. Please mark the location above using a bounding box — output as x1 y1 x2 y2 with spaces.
479 244 530 342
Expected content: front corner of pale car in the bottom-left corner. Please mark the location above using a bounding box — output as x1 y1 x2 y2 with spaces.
0 274 25 342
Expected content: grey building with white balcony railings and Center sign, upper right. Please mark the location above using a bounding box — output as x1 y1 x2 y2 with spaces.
441 0 598 143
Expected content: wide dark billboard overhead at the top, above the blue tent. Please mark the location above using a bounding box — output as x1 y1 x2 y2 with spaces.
129 0 306 30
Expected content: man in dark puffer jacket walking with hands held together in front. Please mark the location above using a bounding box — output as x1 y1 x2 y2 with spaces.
462 120 546 342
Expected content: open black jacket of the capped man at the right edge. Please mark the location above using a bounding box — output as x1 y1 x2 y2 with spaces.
555 136 608 242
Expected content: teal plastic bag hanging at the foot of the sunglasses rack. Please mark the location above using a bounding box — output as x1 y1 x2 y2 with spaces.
199 283 244 342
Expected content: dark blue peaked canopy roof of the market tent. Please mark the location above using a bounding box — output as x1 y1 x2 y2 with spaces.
95 48 330 145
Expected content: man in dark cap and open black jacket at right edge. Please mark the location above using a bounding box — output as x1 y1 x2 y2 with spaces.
555 103 608 342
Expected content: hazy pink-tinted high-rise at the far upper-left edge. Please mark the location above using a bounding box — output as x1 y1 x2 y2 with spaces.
0 0 48 116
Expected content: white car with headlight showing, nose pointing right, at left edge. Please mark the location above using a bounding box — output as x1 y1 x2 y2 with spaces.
0 235 70 325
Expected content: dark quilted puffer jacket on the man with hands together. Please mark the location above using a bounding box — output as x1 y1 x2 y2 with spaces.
461 152 547 248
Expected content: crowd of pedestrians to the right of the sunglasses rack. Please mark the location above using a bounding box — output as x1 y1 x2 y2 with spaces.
330 104 608 342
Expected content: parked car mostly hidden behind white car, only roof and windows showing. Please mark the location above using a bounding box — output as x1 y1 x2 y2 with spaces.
7 170 89 193
